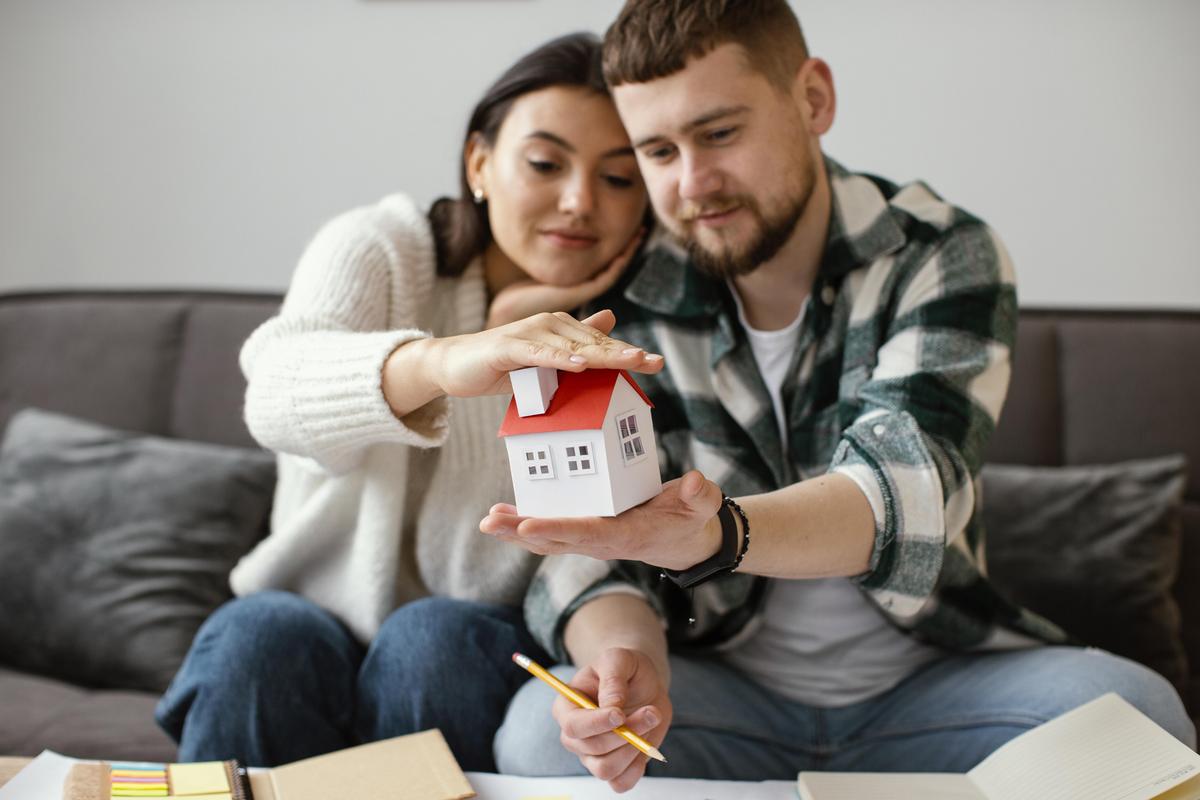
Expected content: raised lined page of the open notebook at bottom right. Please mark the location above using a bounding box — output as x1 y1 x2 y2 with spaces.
967 692 1200 800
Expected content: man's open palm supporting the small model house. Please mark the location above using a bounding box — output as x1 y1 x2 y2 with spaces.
479 470 721 570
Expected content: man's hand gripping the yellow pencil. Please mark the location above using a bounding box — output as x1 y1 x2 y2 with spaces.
552 648 673 792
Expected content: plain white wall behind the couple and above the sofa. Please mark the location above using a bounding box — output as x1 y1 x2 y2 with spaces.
0 0 1200 308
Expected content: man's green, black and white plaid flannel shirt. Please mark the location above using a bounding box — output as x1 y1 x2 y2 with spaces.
526 158 1067 658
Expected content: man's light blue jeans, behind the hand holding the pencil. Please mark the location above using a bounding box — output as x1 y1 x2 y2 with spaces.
496 646 1195 781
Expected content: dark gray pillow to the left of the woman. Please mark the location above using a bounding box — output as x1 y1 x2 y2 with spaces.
0 409 275 692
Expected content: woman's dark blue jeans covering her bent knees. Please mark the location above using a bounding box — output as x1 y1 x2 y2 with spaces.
155 591 547 771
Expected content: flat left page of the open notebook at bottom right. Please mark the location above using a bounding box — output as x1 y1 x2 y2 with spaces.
797 771 988 800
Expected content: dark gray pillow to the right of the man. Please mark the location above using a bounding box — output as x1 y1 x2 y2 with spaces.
983 456 1188 691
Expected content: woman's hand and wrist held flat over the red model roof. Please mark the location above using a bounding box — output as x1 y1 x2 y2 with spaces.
383 309 662 417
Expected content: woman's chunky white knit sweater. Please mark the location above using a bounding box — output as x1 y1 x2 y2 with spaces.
230 194 556 642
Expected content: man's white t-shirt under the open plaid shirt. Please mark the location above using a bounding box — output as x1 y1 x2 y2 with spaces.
725 283 942 708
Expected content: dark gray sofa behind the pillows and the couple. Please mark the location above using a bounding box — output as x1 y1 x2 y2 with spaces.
0 291 1200 759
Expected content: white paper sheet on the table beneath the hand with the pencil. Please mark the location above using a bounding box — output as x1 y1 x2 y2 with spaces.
467 772 796 800
